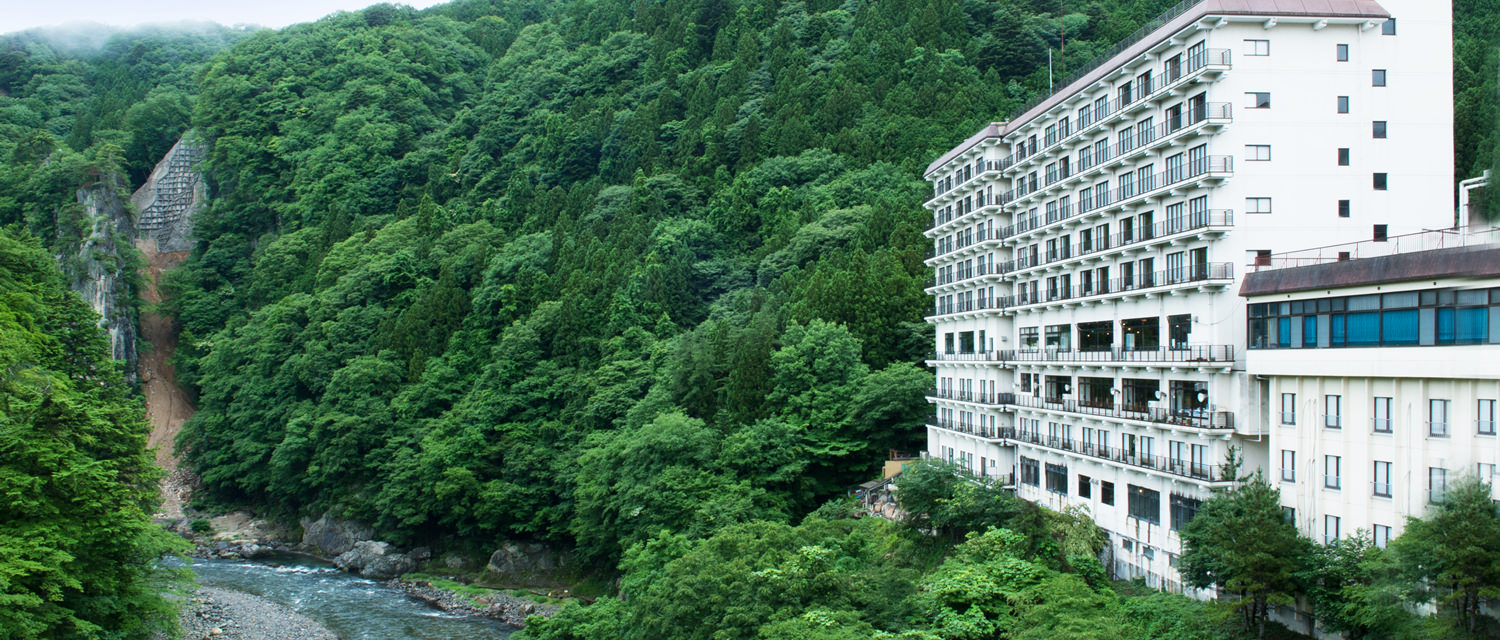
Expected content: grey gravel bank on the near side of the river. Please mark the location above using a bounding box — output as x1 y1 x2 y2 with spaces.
182 586 339 640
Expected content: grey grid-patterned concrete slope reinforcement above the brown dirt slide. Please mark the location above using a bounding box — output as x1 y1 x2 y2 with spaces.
131 133 209 253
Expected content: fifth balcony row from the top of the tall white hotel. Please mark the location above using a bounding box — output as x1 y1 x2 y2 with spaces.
927 262 1235 321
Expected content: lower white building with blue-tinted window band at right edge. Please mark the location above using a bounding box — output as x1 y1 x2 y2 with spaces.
1241 238 1500 547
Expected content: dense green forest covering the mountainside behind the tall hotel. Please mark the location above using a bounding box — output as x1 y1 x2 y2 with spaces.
0 0 1500 639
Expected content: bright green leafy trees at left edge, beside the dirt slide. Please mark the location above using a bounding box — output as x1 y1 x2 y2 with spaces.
0 228 180 639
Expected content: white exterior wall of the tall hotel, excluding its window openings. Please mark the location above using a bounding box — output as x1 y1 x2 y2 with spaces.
927 0 1454 588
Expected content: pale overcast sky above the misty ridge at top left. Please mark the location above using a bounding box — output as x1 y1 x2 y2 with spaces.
0 0 443 33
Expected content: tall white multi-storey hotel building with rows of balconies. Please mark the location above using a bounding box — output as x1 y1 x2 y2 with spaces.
926 0 1454 589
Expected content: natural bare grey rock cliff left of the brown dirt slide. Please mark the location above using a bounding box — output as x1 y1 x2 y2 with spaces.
68 177 137 384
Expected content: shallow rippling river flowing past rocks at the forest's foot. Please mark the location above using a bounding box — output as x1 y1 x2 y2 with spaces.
191 555 515 640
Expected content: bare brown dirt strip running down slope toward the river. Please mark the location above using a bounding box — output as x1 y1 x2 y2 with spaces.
137 240 197 520
